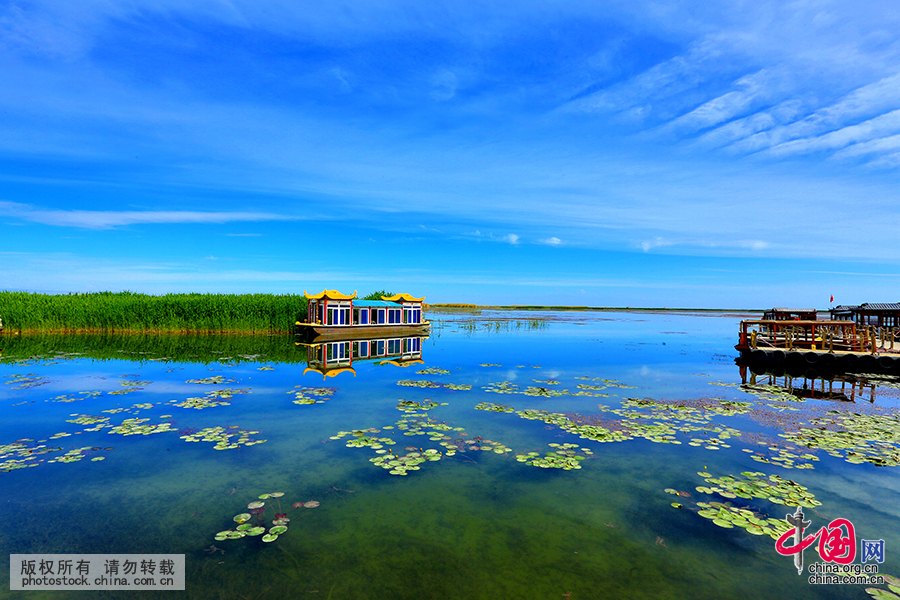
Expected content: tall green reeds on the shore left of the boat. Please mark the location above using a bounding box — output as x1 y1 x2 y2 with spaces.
0 291 306 333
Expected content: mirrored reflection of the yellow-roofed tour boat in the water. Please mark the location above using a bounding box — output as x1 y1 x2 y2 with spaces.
295 336 427 379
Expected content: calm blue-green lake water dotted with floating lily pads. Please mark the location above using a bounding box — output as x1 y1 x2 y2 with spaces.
0 311 900 600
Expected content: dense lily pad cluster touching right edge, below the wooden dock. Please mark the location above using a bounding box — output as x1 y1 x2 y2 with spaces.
779 411 900 467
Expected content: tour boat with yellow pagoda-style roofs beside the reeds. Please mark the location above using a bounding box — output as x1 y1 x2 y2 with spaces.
295 290 431 339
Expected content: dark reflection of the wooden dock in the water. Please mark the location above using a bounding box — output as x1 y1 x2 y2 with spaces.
738 364 900 403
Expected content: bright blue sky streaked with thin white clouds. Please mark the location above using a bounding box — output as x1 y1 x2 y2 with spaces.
0 0 900 308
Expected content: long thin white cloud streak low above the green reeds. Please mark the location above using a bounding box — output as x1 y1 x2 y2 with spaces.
0 202 301 230
